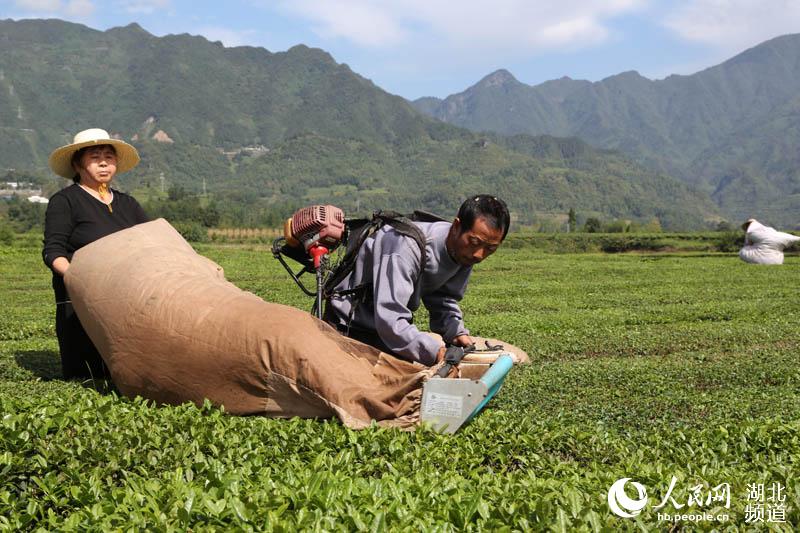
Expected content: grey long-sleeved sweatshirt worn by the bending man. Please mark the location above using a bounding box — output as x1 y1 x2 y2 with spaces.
330 218 472 365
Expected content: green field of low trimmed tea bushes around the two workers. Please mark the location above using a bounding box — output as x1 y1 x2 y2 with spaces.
0 240 800 531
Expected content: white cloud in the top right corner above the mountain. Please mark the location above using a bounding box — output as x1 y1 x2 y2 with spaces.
664 0 800 51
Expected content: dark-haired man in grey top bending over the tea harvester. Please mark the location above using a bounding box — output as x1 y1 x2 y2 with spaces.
324 195 510 365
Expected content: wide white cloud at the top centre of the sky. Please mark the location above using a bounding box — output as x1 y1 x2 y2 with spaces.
282 0 645 53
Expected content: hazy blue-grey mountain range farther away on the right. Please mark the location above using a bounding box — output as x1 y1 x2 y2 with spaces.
414 34 800 227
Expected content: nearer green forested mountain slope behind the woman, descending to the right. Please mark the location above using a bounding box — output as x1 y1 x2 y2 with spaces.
0 20 724 229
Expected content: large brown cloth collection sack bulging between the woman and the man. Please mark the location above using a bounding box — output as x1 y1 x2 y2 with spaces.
65 219 433 428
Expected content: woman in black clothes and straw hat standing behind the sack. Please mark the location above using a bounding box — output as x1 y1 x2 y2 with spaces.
42 128 148 379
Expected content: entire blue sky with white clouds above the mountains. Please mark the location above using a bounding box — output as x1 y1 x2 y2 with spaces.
0 0 800 99
